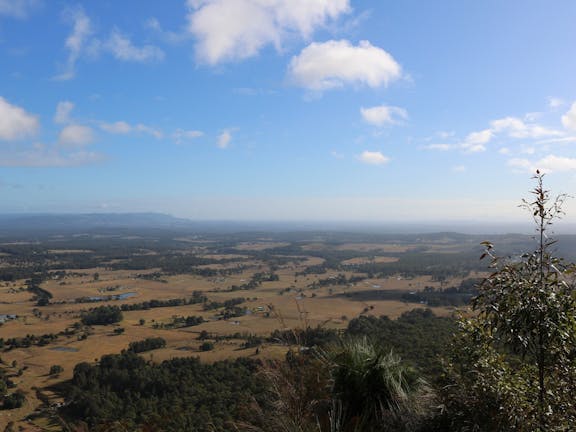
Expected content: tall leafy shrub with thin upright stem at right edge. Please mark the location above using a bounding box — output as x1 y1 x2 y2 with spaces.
438 173 576 431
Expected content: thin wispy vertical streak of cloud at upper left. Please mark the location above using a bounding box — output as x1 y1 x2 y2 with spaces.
55 8 92 80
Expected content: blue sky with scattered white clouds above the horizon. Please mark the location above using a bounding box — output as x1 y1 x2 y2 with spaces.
0 0 576 223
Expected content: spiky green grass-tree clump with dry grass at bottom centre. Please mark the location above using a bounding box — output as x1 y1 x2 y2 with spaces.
245 338 434 432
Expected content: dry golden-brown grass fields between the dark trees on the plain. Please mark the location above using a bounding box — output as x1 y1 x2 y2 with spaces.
0 238 482 431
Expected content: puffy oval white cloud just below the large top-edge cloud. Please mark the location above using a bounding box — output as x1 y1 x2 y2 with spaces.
288 40 402 91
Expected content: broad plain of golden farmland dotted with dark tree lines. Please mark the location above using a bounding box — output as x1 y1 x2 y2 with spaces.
0 221 564 430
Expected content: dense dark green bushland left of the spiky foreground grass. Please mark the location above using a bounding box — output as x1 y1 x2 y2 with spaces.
64 351 264 432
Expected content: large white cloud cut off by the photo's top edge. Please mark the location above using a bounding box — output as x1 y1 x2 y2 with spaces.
187 0 350 65
